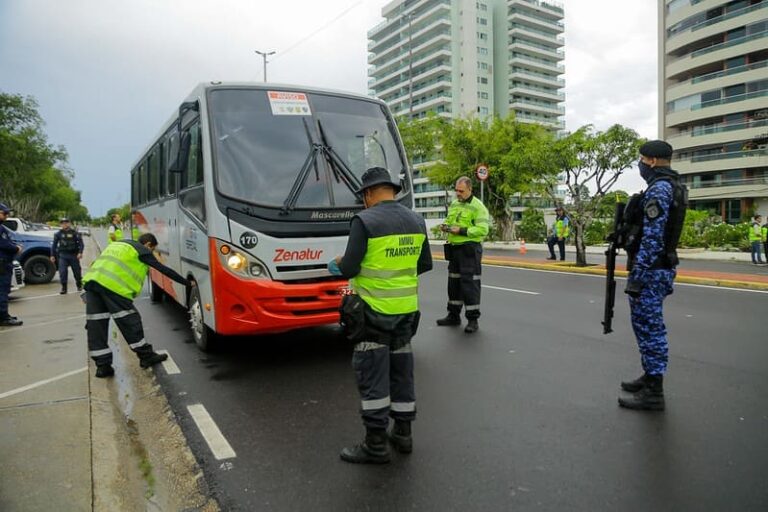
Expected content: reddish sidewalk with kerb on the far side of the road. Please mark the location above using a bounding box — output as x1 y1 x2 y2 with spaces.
430 240 768 290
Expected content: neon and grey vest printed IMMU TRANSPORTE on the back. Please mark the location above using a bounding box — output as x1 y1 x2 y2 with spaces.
350 202 426 315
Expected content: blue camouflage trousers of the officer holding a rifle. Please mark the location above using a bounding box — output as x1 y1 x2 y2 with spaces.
629 270 676 375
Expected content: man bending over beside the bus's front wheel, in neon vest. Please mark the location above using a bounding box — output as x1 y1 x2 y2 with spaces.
83 233 189 378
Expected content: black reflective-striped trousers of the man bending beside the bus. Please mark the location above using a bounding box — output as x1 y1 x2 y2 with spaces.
85 281 153 366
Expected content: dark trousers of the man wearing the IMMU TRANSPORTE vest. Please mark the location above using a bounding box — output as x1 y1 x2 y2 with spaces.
352 313 418 429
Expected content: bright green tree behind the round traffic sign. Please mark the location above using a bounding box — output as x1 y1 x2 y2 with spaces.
428 116 557 240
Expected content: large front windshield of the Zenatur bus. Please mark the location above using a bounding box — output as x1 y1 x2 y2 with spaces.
209 89 405 208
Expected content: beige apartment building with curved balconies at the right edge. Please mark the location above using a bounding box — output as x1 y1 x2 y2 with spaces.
659 0 768 223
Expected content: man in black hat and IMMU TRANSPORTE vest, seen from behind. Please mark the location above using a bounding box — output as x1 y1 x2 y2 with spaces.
328 167 432 464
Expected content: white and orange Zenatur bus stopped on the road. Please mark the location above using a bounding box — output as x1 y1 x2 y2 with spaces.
131 82 413 350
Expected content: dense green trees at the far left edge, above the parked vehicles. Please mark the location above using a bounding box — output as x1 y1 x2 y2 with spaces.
0 93 88 220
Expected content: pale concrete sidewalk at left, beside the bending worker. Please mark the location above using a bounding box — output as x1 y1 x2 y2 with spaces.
0 239 218 512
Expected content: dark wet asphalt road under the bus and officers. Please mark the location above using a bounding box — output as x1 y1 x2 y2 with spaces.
137 262 768 511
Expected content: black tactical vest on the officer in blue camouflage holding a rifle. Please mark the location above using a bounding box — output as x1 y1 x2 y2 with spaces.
619 169 688 270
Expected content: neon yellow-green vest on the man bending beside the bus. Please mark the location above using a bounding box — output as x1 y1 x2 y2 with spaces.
83 242 149 299
